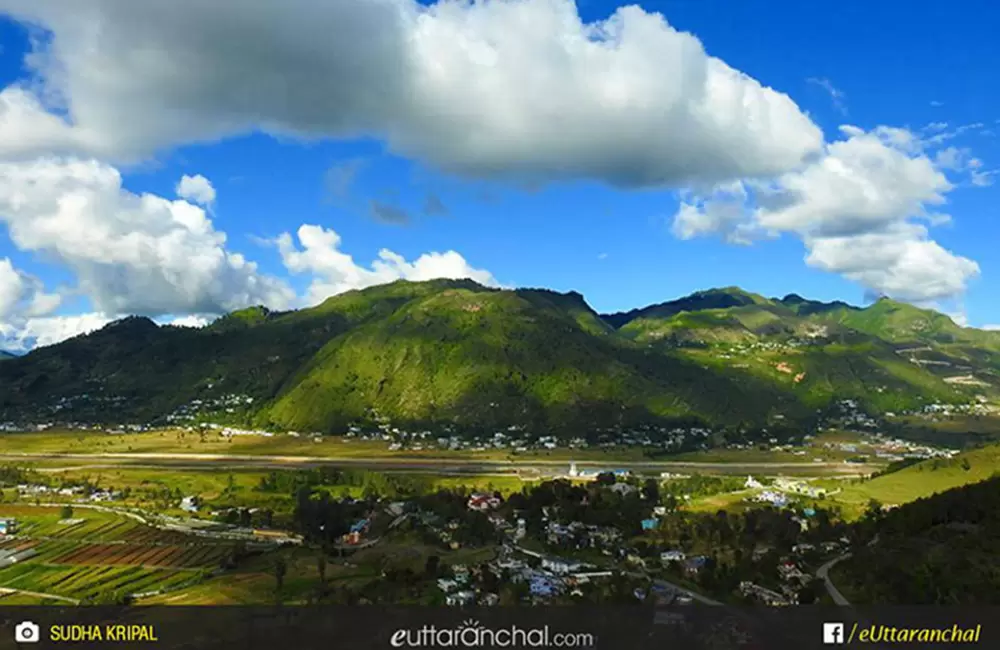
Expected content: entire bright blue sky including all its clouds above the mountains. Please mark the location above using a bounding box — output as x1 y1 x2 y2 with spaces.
0 0 1000 347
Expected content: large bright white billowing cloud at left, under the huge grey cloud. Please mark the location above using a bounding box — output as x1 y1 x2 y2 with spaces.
0 158 294 315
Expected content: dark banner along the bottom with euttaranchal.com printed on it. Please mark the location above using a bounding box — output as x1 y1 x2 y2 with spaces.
0 606 1000 650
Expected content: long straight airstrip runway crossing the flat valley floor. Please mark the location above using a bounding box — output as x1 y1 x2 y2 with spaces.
0 452 872 474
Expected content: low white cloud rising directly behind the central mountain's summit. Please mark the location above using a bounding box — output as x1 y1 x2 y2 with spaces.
276 224 497 304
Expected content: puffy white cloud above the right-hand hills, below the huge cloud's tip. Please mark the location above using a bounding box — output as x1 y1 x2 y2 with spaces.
674 127 979 302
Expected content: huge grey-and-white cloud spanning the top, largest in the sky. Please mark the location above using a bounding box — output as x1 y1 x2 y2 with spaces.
0 0 822 186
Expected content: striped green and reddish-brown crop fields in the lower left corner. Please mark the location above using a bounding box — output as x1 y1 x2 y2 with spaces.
0 505 244 605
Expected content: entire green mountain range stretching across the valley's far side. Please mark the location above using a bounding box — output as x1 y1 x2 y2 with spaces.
0 280 1000 433
